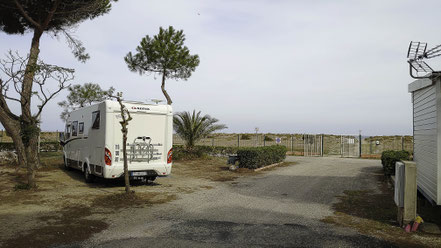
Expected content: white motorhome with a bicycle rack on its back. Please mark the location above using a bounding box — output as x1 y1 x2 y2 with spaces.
61 100 173 182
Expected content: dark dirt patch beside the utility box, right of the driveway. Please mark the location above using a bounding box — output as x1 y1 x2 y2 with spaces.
323 169 441 247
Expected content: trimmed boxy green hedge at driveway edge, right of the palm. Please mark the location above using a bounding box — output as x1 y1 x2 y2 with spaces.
237 145 287 169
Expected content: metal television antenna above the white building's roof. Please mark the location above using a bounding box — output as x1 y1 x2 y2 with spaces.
407 41 441 79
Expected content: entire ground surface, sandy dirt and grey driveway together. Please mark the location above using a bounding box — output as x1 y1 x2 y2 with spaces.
0 157 441 248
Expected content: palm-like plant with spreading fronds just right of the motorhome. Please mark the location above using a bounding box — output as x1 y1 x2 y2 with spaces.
173 110 227 150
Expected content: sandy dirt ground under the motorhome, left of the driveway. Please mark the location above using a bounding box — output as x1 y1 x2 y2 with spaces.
0 153 262 248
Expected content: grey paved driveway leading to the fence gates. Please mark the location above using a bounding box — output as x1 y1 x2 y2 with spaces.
72 157 396 247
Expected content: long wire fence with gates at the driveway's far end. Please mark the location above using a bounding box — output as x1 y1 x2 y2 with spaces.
173 134 413 158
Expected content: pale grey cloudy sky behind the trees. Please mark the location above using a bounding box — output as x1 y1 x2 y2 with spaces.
0 0 441 135
